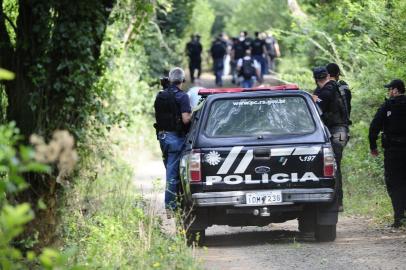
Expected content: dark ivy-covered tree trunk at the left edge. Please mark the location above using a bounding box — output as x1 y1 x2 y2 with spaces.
0 0 115 248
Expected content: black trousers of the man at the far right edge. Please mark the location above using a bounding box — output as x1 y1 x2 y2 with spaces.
384 147 406 222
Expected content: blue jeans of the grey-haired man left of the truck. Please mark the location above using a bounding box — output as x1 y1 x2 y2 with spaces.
158 132 185 210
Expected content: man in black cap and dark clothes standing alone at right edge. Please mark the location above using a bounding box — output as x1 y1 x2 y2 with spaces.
369 79 406 228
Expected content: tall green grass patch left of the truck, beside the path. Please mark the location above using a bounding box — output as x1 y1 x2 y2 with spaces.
61 127 199 269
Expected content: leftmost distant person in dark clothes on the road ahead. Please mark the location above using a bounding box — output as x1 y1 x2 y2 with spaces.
186 35 203 83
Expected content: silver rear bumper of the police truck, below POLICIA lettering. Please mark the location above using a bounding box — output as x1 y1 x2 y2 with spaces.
192 188 334 207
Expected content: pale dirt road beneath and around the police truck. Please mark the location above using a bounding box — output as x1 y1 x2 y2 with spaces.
135 74 406 270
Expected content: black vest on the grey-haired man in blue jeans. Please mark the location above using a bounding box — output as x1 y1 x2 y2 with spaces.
154 88 182 132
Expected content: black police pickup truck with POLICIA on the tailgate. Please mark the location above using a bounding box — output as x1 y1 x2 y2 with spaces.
180 85 338 244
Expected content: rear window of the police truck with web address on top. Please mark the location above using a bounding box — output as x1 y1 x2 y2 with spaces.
205 96 315 137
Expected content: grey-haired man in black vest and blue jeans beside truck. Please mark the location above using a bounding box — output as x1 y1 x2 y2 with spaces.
154 67 191 217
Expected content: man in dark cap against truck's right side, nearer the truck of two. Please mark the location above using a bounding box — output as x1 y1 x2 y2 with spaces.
313 67 349 211
